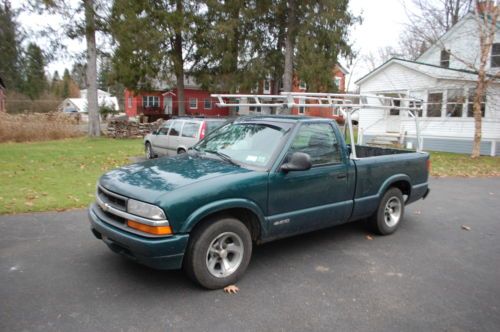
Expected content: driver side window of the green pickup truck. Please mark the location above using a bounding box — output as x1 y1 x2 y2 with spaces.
289 123 342 166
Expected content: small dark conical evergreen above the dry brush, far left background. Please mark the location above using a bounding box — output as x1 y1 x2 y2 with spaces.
23 43 48 99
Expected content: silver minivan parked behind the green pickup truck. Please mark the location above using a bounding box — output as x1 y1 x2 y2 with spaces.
144 118 227 159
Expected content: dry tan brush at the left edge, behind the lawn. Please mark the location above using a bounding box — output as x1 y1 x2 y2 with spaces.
0 112 83 142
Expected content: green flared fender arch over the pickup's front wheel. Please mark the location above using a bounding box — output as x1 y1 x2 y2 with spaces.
180 198 267 233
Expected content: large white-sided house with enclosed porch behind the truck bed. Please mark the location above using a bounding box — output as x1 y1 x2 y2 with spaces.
356 13 500 156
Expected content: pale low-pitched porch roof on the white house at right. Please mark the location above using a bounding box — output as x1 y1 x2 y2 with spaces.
356 58 477 85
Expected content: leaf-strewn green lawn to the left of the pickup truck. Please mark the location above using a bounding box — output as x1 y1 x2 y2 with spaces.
0 138 143 214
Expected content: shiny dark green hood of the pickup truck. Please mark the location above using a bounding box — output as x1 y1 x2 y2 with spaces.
100 154 251 203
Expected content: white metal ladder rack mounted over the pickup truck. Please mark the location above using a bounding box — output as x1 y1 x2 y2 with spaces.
211 92 423 159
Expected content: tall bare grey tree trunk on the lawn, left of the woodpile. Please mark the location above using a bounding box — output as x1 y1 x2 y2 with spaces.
83 0 101 137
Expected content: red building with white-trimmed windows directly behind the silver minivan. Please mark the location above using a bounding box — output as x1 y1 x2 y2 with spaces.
125 78 229 120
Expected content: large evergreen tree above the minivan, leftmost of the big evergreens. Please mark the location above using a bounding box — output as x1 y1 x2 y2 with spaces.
110 0 200 115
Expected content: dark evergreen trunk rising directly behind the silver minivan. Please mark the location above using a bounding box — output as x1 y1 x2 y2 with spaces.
174 0 186 116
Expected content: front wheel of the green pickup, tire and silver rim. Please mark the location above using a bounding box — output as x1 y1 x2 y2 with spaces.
184 218 252 289
